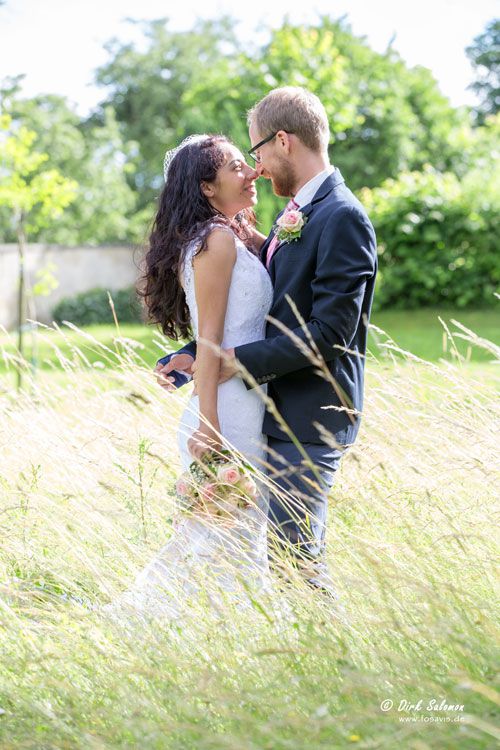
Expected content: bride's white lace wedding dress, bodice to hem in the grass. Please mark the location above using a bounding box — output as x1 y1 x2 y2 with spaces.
107 229 273 618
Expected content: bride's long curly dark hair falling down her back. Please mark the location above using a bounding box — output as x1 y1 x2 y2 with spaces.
137 135 255 340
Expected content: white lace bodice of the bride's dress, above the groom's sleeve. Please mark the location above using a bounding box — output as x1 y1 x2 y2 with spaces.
181 227 273 349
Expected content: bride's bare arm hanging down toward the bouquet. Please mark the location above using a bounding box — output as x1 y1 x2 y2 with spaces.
188 229 236 458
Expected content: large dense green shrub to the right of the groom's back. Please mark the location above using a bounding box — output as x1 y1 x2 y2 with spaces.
362 167 500 309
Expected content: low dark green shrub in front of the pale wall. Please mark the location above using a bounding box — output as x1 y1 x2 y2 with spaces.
52 287 142 326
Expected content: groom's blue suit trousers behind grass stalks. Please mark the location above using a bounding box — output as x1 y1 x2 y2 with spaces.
267 436 345 596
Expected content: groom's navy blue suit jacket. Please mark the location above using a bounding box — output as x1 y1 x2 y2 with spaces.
160 169 377 445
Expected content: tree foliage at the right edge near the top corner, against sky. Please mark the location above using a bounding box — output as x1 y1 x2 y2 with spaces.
466 18 500 123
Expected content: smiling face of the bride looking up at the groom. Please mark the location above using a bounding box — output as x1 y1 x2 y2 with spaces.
201 143 258 218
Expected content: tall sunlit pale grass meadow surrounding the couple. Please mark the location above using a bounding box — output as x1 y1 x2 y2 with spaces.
0 315 498 750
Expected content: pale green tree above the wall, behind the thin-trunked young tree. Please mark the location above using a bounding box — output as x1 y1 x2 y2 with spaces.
0 82 144 245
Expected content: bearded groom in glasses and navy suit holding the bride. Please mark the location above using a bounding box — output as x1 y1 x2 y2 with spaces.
156 86 377 598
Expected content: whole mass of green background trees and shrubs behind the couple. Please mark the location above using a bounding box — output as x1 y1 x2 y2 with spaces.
0 16 500 308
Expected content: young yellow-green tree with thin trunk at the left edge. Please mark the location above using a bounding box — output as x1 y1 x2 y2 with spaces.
0 115 78 386
